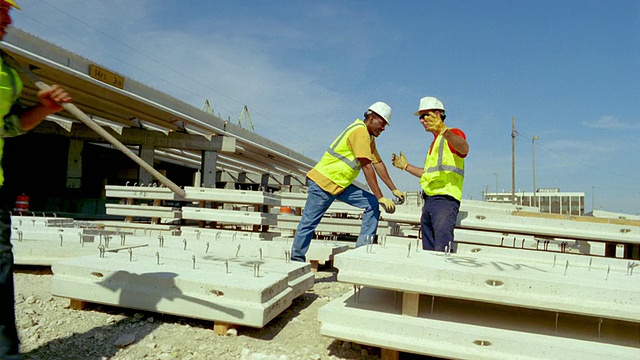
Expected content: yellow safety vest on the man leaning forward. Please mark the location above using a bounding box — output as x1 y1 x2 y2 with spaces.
314 119 366 188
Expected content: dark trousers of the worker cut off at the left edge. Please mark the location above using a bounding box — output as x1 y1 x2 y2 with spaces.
0 202 21 360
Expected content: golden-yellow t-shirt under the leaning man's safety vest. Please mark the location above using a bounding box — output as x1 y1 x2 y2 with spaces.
307 127 382 195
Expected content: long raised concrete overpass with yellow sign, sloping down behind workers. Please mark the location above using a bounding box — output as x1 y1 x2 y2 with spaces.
2 28 315 200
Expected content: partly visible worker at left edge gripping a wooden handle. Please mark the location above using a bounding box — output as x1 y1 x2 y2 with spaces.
0 0 71 360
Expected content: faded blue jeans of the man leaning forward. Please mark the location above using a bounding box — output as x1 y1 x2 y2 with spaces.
291 180 380 262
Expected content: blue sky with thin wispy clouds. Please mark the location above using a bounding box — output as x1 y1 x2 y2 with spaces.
7 0 640 214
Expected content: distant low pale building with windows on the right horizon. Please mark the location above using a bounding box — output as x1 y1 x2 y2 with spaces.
484 188 584 215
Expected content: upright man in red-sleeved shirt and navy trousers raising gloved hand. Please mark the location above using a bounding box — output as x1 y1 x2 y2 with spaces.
391 96 469 251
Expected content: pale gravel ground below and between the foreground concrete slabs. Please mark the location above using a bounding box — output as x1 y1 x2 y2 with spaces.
15 267 428 360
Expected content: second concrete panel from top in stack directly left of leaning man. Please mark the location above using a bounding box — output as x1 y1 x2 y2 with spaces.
182 207 278 225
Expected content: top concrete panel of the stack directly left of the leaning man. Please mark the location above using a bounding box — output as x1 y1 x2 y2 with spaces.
184 186 280 206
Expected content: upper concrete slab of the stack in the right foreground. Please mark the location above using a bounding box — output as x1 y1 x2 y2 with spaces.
334 246 640 322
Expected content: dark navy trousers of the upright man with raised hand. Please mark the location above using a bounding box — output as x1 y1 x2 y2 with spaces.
420 193 460 252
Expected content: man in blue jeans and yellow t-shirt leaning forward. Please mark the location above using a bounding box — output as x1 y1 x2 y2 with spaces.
291 101 405 262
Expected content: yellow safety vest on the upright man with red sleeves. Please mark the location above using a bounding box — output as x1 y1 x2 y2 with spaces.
420 135 464 201
